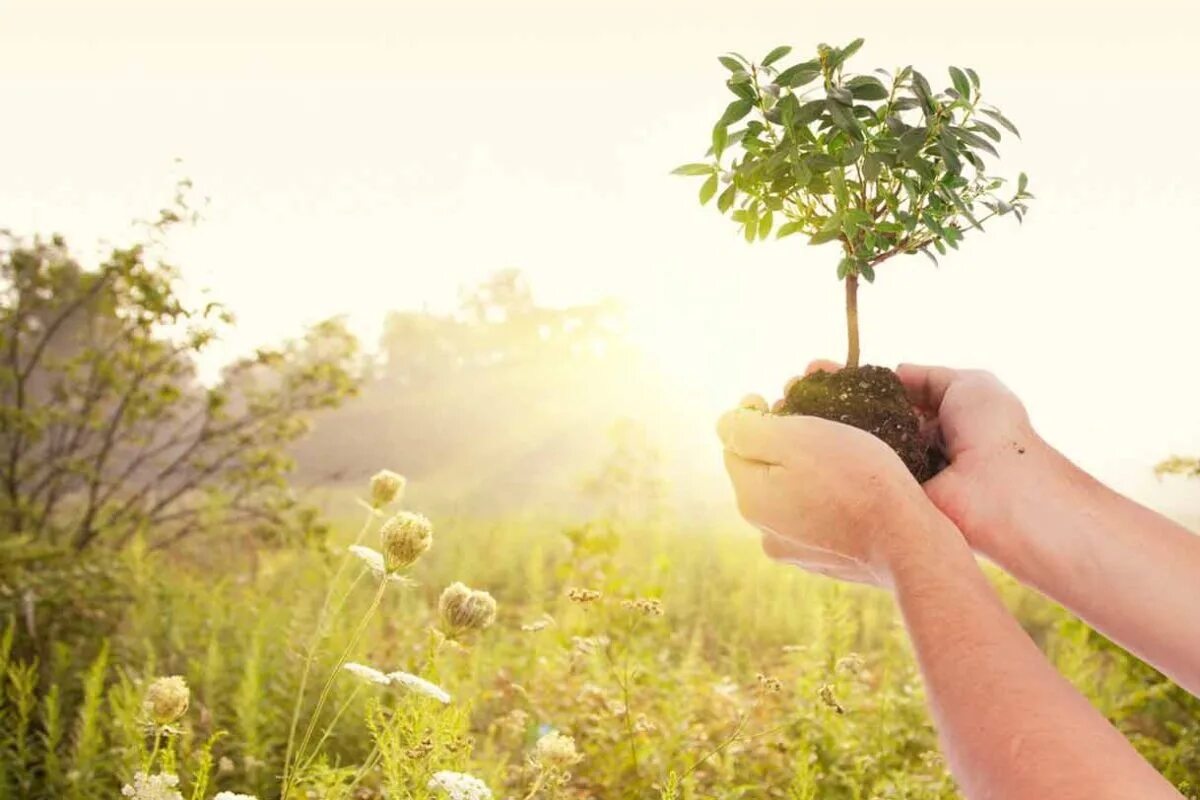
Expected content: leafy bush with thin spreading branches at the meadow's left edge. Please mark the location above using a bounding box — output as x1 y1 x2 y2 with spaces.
0 199 358 551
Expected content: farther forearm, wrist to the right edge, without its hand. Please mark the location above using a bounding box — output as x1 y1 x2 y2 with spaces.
965 441 1200 694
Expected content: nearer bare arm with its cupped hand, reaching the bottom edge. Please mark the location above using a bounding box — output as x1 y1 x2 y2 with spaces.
718 398 1180 800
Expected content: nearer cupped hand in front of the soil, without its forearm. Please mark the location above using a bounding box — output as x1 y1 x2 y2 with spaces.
718 397 932 587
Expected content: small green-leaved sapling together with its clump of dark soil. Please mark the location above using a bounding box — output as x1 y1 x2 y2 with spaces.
674 38 1033 480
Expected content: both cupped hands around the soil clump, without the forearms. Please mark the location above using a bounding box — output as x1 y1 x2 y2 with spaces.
718 361 1040 587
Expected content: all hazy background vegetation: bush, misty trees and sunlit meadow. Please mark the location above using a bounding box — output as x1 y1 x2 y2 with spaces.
0 201 1200 800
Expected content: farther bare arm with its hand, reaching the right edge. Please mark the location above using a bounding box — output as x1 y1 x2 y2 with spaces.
900 366 1200 694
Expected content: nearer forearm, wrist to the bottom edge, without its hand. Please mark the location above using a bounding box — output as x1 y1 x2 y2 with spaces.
892 512 1180 800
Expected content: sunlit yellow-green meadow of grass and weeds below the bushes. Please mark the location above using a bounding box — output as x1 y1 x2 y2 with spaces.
0 479 1200 800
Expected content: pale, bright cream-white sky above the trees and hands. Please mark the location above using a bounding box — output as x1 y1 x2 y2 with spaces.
0 0 1200 509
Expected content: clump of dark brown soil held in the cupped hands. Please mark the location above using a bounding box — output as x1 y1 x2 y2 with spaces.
776 367 946 482
